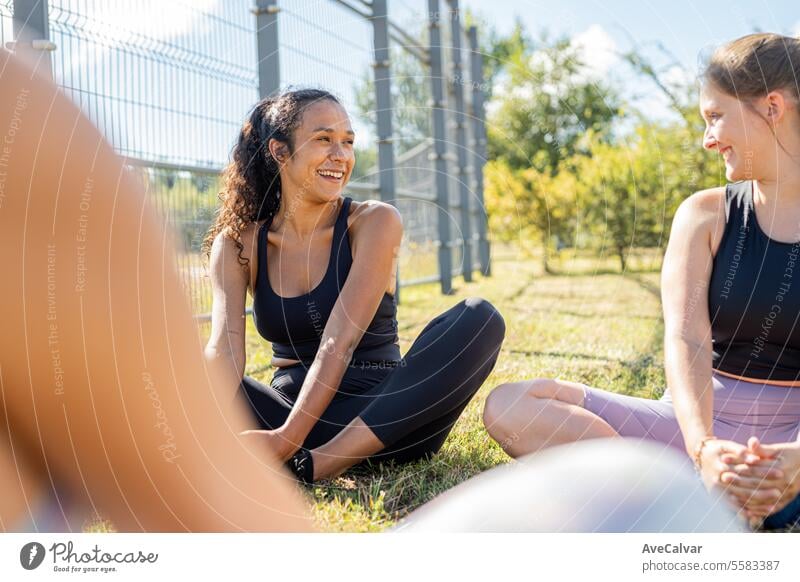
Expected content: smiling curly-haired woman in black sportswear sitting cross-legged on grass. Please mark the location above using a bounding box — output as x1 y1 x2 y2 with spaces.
206 89 505 483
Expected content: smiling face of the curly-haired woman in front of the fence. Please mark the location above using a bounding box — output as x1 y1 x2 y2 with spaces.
281 99 355 201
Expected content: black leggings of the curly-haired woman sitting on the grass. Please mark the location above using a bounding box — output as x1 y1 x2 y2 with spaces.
240 298 505 463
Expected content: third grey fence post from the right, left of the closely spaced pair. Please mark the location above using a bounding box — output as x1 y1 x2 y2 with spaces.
428 0 453 295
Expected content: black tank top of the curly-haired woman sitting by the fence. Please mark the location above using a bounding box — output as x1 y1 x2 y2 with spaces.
253 198 400 364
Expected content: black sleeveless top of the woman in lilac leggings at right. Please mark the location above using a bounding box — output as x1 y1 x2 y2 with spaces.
708 181 800 381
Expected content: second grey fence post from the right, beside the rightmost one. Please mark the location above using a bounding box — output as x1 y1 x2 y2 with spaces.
448 0 473 282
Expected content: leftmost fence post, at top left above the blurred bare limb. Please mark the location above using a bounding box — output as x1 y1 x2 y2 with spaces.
13 0 56 78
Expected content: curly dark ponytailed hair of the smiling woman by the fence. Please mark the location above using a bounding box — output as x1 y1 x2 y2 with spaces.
202 89 341 265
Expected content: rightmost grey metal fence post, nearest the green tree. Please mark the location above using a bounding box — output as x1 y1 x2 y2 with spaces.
469 26 492 277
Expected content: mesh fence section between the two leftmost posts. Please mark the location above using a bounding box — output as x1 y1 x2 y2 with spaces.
49 0 258 315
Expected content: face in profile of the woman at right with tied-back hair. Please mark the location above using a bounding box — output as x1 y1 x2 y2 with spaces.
700 83 776 182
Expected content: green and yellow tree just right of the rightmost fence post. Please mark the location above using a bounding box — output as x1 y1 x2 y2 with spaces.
485 34 620 271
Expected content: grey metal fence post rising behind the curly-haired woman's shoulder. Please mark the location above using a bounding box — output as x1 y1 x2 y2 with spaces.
372 0 400 301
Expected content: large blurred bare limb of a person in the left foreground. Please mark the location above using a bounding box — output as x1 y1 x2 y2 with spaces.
0 50 310 531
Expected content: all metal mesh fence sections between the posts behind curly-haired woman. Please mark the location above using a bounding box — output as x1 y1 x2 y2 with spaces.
9 0 490 318
